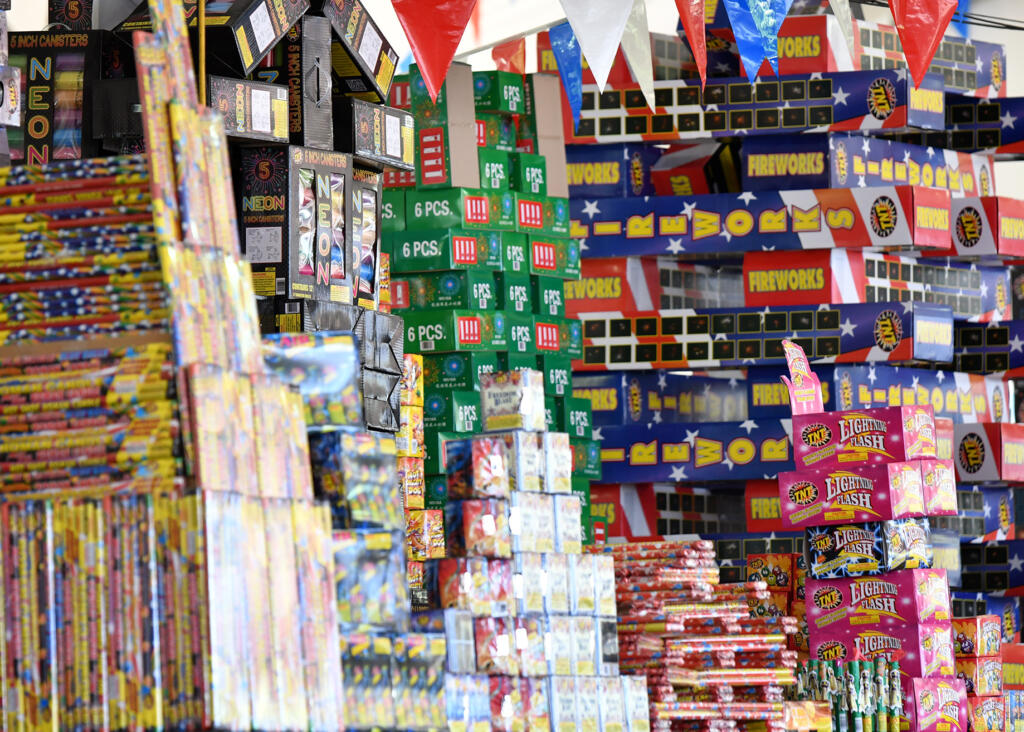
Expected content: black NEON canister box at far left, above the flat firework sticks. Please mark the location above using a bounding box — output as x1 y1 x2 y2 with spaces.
7 31 134 165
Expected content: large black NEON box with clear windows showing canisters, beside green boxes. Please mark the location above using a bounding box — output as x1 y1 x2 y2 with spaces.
234 145 362 304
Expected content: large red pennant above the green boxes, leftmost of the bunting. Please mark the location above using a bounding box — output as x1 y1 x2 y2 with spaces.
391 0 476 101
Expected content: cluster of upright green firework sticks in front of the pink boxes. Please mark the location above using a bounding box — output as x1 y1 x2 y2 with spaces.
795 658 903 732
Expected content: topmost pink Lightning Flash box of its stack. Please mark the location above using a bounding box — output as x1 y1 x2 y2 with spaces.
793 405 935 470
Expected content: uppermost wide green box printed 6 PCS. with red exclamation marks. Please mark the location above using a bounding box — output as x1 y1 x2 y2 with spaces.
406 188 516 231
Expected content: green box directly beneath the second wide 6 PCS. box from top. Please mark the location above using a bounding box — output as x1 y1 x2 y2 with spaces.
391 269 499 310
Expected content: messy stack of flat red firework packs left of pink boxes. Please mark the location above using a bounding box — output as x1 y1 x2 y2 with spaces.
603 541 831 730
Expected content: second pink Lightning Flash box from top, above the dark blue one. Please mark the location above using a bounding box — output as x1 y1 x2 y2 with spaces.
778 462 925 528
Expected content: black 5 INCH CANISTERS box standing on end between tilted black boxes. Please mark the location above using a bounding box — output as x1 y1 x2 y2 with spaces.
245 15 329 153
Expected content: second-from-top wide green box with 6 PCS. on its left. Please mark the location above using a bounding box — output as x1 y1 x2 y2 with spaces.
389 229 503 275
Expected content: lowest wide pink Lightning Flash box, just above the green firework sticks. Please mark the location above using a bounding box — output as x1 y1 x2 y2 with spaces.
808 622 956 679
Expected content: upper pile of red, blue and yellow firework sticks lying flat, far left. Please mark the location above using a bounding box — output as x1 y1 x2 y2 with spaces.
0 157 170 344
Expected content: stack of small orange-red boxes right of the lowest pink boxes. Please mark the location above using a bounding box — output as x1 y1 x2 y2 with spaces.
952 615 1006 732
